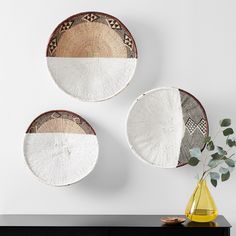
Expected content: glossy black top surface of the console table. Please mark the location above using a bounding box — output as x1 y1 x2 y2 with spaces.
0 215 231 228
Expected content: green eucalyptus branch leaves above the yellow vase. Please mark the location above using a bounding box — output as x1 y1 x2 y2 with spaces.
188 119 236 187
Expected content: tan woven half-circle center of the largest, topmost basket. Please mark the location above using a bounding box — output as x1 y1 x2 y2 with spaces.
55 22 127 58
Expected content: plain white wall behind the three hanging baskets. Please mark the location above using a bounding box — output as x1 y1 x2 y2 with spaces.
0 0 236 232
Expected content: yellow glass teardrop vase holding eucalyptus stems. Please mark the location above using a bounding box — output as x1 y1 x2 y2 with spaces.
185 179 218 222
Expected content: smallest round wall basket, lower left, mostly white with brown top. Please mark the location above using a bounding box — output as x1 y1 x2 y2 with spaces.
24 110 98 186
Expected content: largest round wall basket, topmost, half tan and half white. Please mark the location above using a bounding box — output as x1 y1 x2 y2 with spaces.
47 12 137 101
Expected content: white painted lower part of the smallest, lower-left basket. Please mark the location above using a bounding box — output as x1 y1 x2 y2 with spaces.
24 133 98 186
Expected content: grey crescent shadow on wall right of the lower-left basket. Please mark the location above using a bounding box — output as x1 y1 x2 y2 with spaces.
76 121 130 194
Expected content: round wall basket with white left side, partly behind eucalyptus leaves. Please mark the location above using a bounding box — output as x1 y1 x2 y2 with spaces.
127 88 208 168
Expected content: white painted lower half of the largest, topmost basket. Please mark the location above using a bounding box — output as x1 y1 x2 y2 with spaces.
47 57 137 101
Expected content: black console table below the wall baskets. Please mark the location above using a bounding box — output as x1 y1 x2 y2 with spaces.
0 215 231 236
